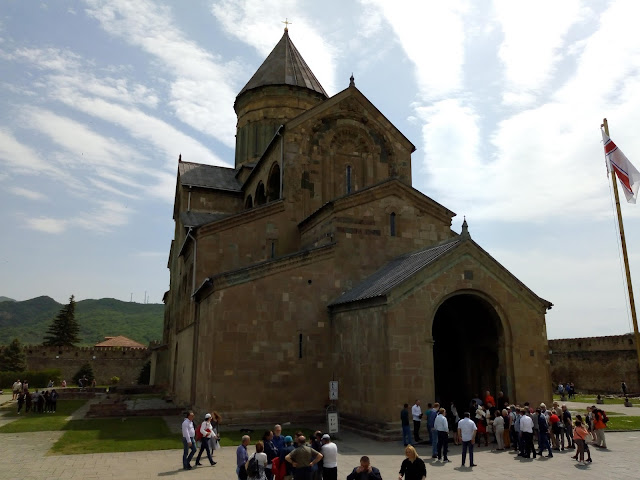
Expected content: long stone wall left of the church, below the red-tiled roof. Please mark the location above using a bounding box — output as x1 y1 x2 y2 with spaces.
24 346 150 385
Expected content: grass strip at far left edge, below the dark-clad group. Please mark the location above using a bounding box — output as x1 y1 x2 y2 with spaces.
0 400 86 433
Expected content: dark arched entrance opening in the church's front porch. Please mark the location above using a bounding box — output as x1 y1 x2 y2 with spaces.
432 293 507 410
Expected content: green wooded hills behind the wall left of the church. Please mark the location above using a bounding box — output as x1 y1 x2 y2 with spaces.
0 296 164 346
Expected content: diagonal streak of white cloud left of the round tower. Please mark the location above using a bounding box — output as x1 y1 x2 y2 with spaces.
86 0 237 147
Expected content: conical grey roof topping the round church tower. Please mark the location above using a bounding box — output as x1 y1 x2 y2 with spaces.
238 29 328 97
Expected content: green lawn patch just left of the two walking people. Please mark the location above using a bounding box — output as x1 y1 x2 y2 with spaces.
50 417 182 455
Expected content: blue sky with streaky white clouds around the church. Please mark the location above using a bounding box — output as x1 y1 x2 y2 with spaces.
0 0 640 338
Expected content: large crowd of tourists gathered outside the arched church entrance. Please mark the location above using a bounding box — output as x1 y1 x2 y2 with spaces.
410 391 608 467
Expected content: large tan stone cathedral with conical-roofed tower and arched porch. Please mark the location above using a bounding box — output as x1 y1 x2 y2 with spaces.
152 29 552 433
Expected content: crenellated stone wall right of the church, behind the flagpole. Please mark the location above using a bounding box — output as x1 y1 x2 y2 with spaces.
549 333 640 394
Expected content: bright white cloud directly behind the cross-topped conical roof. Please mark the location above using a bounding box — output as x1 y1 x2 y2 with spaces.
211 0 346 95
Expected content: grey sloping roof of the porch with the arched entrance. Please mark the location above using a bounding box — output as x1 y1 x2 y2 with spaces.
329 237 462 307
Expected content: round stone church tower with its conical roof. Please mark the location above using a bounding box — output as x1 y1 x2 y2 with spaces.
233 28 328 168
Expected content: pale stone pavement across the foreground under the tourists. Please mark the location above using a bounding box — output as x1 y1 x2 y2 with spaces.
0 426 640 480
